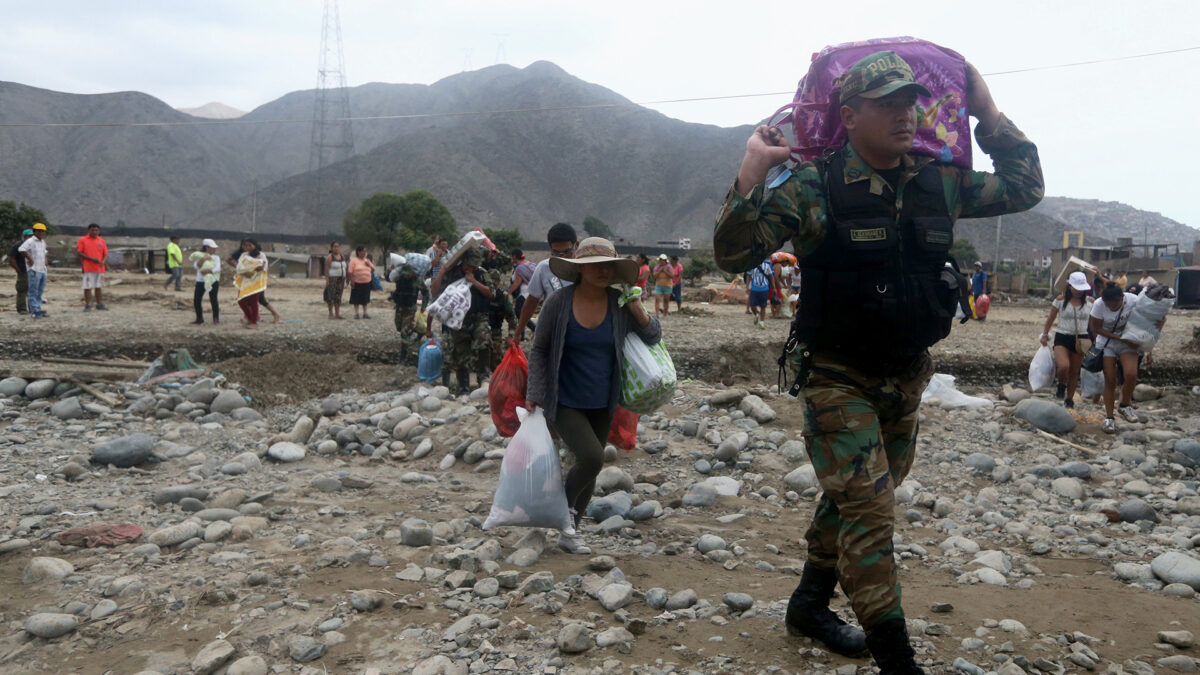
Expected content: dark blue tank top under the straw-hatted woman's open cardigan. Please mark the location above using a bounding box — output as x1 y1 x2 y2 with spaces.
558 311 617 410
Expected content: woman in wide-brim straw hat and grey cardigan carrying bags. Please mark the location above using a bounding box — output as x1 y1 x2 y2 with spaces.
526 237 662 554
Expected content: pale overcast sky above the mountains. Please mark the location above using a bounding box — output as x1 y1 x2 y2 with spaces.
0 0 1200 227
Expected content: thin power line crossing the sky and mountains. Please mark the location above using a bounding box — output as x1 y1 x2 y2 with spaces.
0 46 1200 129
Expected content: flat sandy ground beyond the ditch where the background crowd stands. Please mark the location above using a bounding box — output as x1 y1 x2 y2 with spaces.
0 266 1200 389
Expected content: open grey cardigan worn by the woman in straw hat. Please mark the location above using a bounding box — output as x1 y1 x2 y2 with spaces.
526 286 662 422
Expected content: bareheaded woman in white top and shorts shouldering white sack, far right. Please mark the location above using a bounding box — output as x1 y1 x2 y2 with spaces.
1091 282 1138 434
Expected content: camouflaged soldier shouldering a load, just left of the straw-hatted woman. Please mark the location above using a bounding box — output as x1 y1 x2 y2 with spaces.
433 249 499 394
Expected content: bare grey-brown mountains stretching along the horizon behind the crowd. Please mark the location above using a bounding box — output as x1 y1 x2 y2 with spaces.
0 61 1200 247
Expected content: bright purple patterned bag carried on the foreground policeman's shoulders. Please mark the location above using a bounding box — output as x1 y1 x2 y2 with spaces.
772 37 971 168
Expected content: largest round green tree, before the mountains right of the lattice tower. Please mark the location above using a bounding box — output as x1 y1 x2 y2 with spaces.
342 190 455 251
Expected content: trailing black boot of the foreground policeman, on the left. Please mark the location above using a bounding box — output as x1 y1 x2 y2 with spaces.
784 565 866 656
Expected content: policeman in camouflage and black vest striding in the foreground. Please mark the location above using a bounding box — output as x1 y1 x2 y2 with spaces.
713 52 1044 674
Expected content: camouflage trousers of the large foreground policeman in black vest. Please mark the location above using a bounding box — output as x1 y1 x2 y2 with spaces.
804 353 934 627
